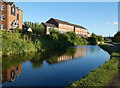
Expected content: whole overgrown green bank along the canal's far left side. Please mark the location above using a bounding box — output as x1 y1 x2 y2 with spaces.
1 31 88 56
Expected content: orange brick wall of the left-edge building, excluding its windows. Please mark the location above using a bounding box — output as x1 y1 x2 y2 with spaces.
0 2 23 30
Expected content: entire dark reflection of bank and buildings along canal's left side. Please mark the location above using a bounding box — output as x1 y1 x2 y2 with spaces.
2 47 86 82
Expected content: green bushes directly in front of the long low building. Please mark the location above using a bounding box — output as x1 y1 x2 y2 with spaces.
50 28 88 45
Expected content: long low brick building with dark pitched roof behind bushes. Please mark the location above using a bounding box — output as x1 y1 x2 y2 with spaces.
42 18 90 37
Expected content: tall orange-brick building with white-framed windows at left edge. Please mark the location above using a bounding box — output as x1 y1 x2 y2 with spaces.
0 1 23 30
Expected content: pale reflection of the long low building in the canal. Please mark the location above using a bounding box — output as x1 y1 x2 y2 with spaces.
47 47 87 64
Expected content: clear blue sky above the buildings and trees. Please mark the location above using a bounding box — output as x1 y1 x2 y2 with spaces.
15 2 118 36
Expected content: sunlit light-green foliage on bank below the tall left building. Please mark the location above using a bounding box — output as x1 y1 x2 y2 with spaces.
2 31 41 55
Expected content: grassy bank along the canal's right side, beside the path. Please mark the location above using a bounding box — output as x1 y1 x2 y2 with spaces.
68 44 120 88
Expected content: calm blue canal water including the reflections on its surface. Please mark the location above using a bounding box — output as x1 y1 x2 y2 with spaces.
2 45 110 86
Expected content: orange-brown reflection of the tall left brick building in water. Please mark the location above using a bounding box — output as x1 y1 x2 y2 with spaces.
2 64 22 82
